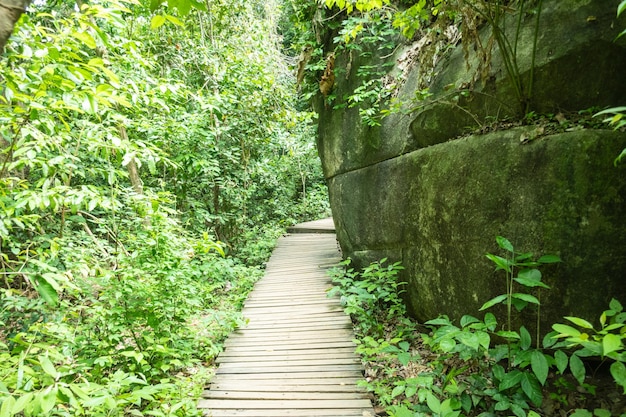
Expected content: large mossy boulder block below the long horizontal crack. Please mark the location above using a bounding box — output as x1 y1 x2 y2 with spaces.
329 129 626 329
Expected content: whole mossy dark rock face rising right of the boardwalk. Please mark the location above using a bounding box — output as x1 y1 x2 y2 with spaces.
318 0 626 330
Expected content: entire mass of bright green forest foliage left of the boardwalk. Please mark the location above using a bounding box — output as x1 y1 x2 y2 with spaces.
0 0 328 417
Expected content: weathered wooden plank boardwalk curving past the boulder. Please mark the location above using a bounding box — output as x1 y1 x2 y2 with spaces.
199 219 374 417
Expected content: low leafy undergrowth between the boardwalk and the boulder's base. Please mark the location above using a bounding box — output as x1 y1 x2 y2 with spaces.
330 237 626 417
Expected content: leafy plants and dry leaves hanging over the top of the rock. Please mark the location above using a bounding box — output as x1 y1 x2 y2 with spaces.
294 0 542 127
